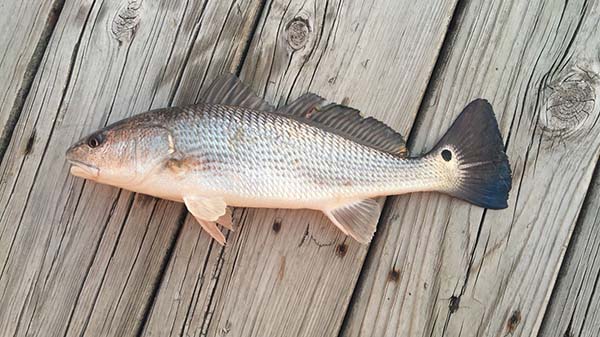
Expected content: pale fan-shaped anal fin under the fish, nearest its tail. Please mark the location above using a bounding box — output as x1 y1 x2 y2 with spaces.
324 199 380 244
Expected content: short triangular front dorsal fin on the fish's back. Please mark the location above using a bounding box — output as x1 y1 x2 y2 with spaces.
204 74 275 111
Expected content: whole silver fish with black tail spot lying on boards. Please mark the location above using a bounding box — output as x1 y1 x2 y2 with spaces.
66 74 512 245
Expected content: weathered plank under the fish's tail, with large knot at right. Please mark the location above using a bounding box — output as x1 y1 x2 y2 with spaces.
342 0 600 337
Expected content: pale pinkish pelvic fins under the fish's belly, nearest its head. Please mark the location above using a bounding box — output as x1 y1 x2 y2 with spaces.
183 196 227 245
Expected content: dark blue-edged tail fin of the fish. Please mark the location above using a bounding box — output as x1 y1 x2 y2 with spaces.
432 99 512 209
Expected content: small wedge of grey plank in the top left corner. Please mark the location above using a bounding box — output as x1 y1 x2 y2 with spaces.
0 0 62 159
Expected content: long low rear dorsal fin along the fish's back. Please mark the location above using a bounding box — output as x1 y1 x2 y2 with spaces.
277 93 408 157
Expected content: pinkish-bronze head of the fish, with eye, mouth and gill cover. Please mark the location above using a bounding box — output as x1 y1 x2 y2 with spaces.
66 119 173 188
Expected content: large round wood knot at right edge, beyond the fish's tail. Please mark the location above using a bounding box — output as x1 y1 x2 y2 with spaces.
540 72 598 139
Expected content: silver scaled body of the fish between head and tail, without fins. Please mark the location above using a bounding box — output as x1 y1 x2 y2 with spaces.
136 104 451 209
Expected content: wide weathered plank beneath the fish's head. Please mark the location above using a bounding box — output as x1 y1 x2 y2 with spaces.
0 0 260 336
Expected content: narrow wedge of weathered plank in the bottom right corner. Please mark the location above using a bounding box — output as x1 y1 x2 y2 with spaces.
538 168 600 337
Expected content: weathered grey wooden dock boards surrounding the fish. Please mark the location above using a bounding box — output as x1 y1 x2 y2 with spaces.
0 0 600 337
